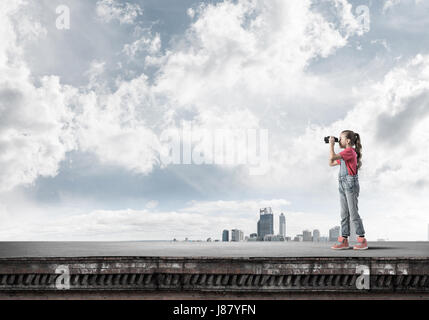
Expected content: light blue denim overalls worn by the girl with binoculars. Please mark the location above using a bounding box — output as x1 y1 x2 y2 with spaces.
338 158 365 237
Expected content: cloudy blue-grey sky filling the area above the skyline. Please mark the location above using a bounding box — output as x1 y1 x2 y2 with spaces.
0 0 429 241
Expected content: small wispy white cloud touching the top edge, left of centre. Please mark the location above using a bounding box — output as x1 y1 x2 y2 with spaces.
96 0 143 24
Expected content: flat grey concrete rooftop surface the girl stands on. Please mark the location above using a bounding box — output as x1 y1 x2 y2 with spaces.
0 241 429 258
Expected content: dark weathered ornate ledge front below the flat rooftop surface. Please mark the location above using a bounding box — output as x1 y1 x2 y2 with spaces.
0 243 429 299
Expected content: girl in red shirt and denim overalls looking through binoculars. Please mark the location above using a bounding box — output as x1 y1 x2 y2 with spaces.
329 130 368 250
